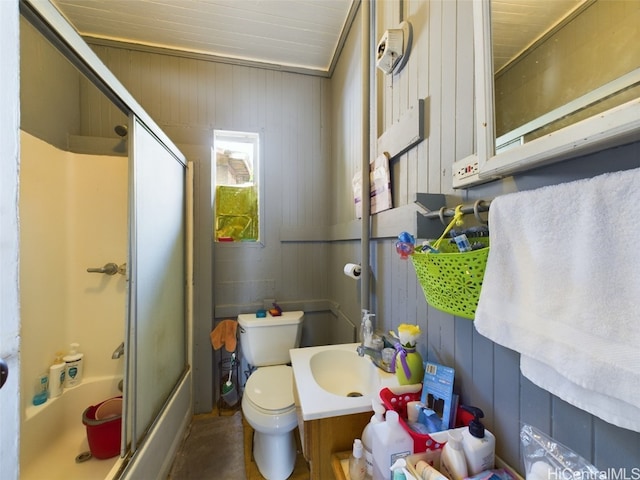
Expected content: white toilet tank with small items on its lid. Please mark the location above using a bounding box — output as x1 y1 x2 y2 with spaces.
238 311 304 367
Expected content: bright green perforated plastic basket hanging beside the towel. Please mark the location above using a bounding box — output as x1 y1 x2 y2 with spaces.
411 237 489 320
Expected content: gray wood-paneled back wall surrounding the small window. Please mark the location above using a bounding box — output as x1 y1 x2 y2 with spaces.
94 41 331 412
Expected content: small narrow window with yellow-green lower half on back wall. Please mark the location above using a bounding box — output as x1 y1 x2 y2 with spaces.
213 130 260 242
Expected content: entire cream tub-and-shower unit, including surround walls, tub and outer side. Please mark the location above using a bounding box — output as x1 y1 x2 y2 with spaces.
20 132 192 480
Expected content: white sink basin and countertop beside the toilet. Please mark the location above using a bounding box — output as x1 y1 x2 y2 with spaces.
289 343 398 420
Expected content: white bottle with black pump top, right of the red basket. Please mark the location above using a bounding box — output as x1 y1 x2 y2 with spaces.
461 405 496 475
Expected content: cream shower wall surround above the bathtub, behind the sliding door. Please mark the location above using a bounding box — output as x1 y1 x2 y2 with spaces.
20 132 128 409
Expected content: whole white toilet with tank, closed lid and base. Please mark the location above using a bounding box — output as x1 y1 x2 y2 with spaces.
238 311 304 480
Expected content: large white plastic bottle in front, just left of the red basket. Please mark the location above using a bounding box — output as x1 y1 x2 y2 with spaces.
372 410 413 480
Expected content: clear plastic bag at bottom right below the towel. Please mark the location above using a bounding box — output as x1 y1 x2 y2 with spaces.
520 424 605 480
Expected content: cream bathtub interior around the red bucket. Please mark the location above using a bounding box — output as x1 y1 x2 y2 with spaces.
20 377 121 480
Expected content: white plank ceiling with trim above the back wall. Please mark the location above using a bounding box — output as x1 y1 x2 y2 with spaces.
51 0 360 73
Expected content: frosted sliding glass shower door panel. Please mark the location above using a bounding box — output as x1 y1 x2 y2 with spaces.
125 116 187 451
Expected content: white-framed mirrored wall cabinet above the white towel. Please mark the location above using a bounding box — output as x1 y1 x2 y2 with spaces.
454 0 640 187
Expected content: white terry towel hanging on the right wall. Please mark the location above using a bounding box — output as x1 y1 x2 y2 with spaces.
475 169 640 431
